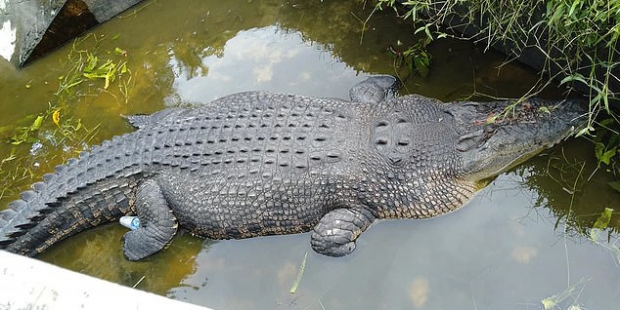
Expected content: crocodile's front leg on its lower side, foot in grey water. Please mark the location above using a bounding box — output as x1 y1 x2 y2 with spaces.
311 208 375 256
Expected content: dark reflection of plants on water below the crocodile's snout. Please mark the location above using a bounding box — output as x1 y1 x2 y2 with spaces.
517 140 620 235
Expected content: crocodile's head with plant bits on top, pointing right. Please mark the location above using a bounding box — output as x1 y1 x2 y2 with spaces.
446 99 585 182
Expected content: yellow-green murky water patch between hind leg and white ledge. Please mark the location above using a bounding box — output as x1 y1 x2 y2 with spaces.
41 224 210 295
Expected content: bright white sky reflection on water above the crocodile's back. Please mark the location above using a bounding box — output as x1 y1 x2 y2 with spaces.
169 25 363 103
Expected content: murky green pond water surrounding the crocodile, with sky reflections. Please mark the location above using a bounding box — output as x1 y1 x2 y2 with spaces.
0 0 620 309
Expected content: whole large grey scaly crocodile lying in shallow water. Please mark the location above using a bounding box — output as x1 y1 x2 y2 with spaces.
0 77 584 260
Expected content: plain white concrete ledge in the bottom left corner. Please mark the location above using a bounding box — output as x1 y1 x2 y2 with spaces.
0 251 209 310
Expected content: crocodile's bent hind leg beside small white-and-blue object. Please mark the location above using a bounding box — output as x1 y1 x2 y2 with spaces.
123 180 178 261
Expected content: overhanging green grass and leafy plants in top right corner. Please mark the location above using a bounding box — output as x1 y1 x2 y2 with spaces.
377 0 620 190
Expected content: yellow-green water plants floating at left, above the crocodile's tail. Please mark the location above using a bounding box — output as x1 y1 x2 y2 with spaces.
0 34 134 198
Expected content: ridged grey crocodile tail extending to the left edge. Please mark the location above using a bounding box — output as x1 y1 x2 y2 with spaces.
0 133 141 255
